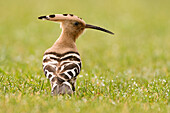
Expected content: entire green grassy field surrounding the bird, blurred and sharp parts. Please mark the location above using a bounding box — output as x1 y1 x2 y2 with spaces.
0 0 170 113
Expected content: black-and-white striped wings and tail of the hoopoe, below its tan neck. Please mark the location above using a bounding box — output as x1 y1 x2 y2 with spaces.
43 52 81 95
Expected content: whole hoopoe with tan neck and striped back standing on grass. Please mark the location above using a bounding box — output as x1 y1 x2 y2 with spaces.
38 14 114 95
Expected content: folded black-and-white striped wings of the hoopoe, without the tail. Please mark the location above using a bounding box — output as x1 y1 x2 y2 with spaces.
43 52 81 84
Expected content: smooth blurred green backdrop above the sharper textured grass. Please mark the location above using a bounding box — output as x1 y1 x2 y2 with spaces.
0 0 170 70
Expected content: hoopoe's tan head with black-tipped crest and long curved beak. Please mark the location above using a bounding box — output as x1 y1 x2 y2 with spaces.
38 14 114 37
